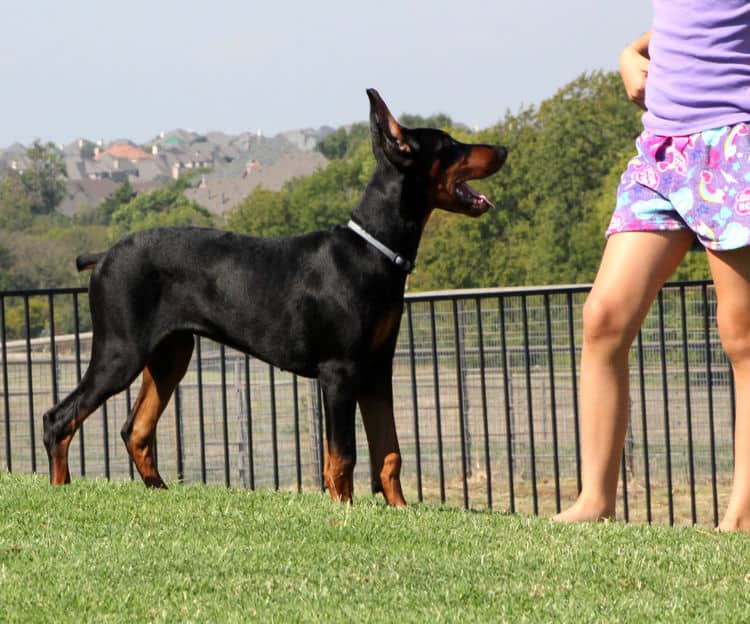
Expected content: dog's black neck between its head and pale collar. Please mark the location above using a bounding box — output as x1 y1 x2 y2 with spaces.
351 163 426 262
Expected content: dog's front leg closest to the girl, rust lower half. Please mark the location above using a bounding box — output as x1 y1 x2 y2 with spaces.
358 367 406 507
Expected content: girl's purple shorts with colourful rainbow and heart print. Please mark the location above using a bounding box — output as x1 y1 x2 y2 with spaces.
606 123 750 251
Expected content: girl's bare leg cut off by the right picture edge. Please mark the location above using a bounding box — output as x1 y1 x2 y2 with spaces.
708 247 750 531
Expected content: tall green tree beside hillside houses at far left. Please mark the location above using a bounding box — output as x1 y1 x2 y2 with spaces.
21 139 65 214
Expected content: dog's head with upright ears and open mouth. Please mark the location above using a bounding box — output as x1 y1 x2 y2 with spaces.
367 89 507 217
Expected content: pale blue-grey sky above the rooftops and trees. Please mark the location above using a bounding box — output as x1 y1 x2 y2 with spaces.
0 0 651 146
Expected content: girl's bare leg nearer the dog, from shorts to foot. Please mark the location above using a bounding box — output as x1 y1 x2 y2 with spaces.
553 230 694 522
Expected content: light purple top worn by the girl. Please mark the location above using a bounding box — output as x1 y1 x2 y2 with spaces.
643 0 750 136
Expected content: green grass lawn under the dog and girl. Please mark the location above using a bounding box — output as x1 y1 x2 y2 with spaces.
0 473 750 624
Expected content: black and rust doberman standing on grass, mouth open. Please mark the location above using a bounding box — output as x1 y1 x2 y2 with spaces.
44 89 506 505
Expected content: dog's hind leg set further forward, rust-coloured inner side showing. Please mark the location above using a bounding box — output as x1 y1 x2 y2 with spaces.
121 332 194 488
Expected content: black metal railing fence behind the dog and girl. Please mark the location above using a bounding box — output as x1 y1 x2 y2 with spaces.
0 282 734 525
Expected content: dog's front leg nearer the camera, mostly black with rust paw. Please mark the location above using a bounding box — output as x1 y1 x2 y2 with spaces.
320 370 357 503
